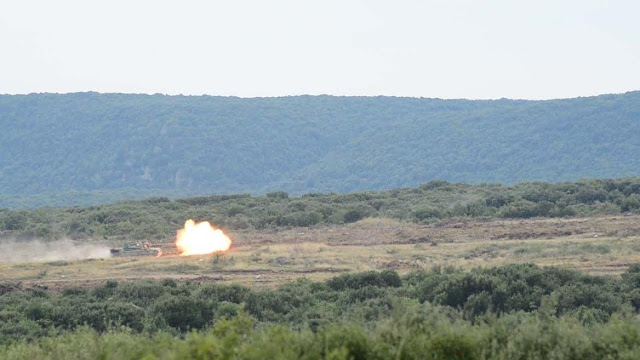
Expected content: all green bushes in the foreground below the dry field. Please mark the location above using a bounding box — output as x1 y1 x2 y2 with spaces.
0 265 640 359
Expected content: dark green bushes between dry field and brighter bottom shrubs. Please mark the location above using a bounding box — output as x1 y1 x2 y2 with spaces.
0 264 640 352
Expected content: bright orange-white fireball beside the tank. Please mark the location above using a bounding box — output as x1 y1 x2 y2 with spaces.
176 219 231 256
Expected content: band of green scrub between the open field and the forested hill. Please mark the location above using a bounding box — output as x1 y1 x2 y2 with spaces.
0 178 640 240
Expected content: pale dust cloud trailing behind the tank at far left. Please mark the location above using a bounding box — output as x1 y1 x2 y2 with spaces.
0 240 110 263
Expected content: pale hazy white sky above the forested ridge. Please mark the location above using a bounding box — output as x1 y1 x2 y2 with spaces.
0 0 640 99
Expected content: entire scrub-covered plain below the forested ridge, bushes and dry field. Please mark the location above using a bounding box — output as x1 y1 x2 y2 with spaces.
0 180 640 359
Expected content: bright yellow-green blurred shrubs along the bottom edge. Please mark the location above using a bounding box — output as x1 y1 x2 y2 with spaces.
0 308 640 360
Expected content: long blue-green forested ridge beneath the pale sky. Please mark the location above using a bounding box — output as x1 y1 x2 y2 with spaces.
0 92 640 207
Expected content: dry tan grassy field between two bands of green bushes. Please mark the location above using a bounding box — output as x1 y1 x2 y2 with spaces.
0 215 640 290
